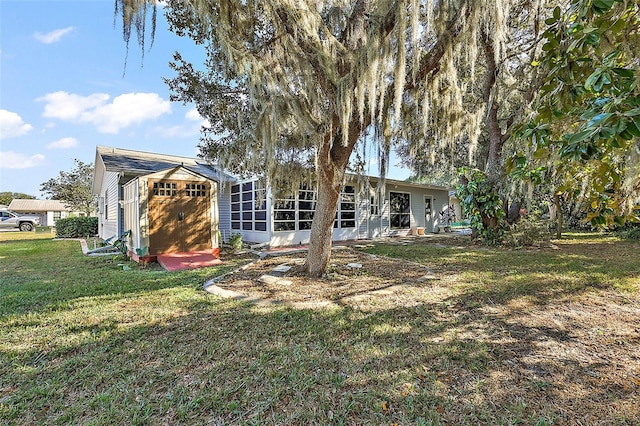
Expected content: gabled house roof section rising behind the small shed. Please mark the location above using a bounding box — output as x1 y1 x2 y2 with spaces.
94 146 236 192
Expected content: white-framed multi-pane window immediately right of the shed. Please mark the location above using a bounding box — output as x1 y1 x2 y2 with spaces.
231 182 267 231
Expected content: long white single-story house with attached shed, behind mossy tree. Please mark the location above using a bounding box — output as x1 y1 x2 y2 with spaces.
93 146 456 255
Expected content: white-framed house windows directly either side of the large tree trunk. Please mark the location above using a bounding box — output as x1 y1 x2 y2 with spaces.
273 186 356 231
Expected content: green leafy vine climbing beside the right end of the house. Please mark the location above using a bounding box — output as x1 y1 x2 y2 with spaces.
456 167 505 245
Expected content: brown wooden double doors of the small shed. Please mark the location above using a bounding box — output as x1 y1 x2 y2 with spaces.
149 179 211 255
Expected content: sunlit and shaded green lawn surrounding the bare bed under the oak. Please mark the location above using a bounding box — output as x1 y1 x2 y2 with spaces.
0 234 640 425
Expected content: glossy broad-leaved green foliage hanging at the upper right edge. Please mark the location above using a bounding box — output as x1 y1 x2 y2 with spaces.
524 0 640 228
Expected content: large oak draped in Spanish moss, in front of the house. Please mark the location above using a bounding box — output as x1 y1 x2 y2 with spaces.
116 0 538 276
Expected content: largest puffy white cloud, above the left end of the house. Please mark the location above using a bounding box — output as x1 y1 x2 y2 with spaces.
37 92 171 133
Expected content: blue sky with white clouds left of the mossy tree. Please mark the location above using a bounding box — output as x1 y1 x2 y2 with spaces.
0 0 408 198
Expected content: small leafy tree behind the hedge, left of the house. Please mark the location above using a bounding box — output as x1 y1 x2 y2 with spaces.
40 159 95 215
